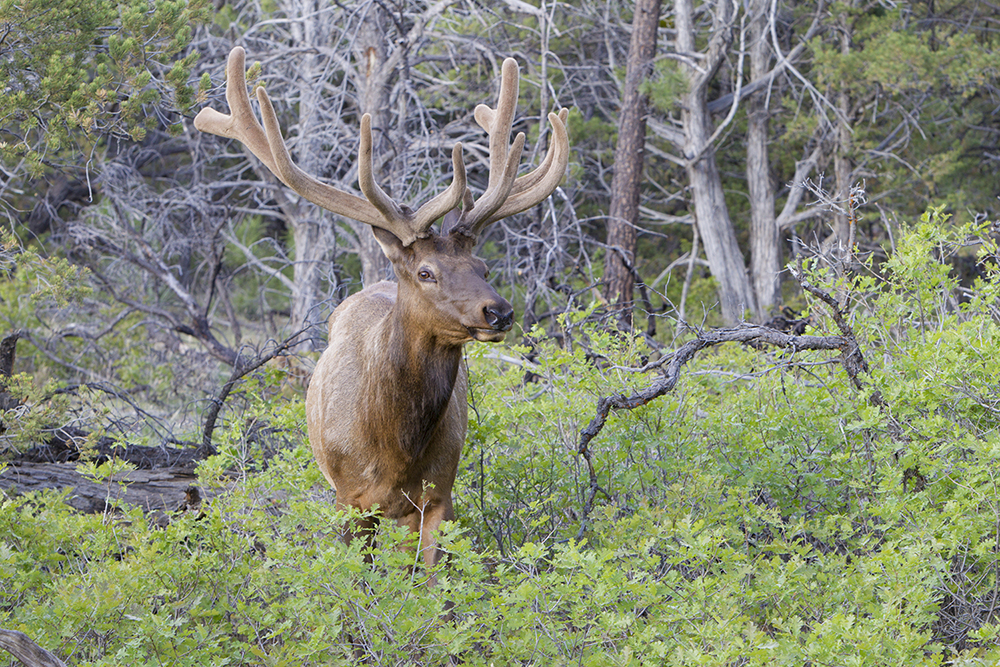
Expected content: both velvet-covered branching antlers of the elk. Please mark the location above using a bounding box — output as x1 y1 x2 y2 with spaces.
194 46 569 246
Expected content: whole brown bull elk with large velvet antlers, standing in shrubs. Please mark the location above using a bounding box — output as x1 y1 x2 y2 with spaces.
194 47 569 566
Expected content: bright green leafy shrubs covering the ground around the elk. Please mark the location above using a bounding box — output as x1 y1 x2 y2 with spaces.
0 212 1000 666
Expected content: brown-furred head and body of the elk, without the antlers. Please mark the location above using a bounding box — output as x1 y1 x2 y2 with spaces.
306 230 512 564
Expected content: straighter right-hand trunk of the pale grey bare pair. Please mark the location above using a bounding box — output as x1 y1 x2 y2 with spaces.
747 0 781 317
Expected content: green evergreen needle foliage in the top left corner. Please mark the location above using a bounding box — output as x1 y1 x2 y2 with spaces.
0 0 207 167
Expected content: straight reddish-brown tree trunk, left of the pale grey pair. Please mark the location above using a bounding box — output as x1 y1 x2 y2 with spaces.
604 0 660 328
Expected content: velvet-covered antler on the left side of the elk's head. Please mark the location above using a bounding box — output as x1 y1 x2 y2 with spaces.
194 46 466 245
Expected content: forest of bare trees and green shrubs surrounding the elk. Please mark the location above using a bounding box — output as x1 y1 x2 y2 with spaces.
0 0 1000 665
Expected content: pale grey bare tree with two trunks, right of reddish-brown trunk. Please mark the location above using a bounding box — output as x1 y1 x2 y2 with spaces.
651 0 829 322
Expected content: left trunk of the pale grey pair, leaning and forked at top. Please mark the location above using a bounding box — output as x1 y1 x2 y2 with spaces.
675 0 756 322
